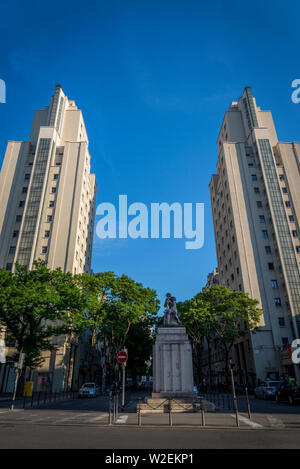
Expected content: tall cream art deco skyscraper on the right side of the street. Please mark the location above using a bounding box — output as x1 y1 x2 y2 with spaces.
210 87 300 379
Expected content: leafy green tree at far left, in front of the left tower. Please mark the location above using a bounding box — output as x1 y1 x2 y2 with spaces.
0 261 85 390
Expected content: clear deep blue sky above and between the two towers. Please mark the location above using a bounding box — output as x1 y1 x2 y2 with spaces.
0 0 300 310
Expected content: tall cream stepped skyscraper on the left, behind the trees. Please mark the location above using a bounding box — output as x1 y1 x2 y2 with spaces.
0 85 96 390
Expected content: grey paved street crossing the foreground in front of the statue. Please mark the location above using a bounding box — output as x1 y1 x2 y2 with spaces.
0 394 300 449
